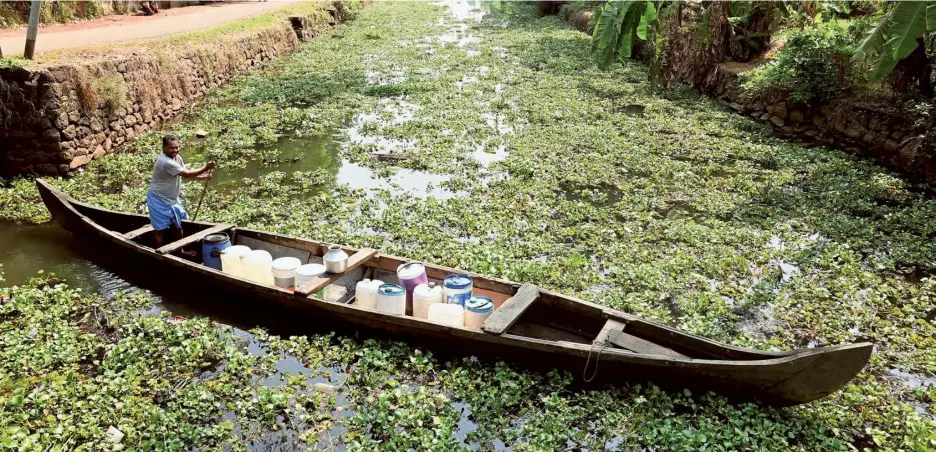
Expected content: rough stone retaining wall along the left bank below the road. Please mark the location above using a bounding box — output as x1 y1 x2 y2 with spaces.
0 1 344 175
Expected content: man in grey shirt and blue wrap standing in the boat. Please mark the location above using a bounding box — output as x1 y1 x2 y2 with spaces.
146 134 215 248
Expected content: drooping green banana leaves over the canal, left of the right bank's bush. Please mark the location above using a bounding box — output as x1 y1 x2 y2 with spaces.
592 0 671 68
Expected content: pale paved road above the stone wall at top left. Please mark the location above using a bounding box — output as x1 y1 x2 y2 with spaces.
0 0 300 56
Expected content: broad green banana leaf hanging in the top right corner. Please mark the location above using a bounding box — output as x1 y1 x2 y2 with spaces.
852 1 936 80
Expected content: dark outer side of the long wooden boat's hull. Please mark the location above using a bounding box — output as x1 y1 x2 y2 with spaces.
37 180 872 406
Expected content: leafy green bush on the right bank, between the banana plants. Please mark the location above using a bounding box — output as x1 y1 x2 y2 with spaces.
743 21 860 102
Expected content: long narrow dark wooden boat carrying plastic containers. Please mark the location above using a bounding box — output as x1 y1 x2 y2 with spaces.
36 179 872 406
